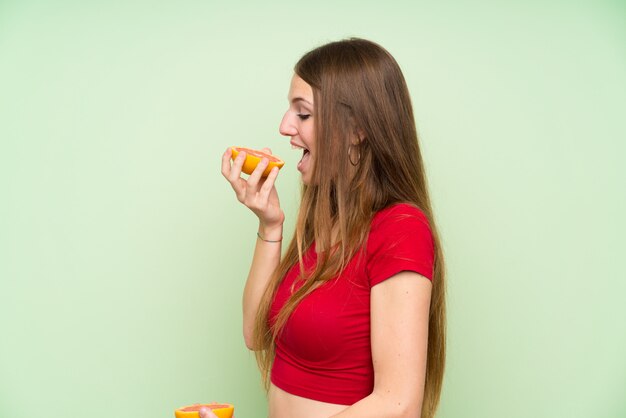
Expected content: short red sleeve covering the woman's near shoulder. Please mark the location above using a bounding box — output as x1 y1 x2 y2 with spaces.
367 203 434 287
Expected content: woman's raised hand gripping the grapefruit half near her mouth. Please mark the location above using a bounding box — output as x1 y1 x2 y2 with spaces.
222 148 285 229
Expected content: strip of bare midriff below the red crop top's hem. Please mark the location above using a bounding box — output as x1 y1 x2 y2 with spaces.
269 385 348 418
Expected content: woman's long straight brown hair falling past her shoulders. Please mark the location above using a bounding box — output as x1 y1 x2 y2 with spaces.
254 38 446 418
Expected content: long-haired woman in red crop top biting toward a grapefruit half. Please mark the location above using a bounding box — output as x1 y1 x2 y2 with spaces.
207 39 445 418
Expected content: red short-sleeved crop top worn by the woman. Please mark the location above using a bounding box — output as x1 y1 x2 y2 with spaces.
270 204 434 405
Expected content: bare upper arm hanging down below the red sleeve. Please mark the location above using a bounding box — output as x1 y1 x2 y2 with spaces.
371 271 432 417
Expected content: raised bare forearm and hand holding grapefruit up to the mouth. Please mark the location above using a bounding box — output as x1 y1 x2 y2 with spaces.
222 148 285 350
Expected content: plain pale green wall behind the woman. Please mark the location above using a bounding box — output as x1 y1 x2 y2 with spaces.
0 0 626 418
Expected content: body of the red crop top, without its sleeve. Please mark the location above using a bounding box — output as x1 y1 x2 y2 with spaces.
270 245 374 405
